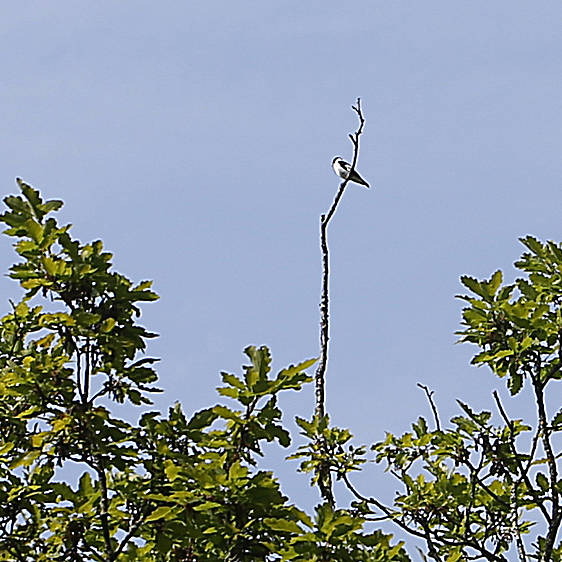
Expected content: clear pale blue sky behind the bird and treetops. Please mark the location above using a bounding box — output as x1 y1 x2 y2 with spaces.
0 0 562 524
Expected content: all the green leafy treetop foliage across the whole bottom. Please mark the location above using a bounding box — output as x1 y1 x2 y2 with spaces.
0 180 562 562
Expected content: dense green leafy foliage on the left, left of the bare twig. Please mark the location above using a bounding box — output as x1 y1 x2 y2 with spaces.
0 180 408 562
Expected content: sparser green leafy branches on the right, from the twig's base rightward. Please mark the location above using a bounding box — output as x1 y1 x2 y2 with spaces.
298 236 562 562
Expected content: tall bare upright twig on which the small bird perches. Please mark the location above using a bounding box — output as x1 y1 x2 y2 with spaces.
315 98 365 505
